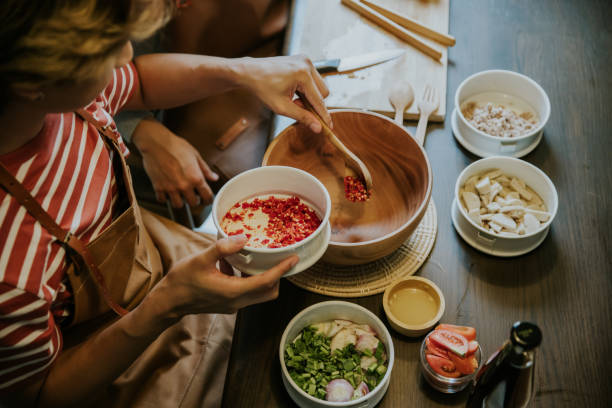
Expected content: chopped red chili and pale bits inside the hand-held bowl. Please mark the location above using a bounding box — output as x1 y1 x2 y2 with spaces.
221 194 321 248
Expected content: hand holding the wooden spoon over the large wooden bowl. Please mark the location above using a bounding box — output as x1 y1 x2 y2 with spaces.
241 55 332 133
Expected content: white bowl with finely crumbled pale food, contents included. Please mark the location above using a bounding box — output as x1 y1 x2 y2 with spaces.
451 70 550 157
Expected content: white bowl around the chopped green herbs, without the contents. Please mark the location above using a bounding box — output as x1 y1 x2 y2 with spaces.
279 300 395 408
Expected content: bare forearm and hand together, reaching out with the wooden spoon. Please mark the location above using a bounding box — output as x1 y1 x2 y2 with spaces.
125 54 332 133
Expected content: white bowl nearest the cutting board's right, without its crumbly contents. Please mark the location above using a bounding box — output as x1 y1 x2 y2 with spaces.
453 70 550 157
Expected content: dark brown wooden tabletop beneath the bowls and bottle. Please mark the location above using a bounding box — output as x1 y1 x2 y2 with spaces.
223 0 612 408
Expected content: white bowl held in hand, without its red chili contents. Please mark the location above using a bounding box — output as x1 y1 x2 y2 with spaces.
212 166 331 276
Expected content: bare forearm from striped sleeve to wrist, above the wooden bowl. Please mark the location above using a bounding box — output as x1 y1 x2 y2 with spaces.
125 54 248 110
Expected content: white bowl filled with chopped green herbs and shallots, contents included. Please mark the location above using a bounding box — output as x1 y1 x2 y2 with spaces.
279 301 395 408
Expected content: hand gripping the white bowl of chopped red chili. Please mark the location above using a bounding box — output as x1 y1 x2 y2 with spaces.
151 235 299 317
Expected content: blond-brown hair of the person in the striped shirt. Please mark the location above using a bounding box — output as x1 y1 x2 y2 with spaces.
0 0 174 111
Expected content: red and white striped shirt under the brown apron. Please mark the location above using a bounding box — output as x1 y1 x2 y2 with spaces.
0 64 138 390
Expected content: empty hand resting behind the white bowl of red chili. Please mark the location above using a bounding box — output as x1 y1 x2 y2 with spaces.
132 118 219 208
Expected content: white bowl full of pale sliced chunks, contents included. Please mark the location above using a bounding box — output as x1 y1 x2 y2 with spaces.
451 156 559 256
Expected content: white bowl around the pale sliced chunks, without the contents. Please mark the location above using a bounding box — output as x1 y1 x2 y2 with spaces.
451 156 559 256
